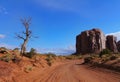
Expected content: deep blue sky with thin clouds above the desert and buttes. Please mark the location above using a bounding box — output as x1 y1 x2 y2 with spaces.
0 0 120 54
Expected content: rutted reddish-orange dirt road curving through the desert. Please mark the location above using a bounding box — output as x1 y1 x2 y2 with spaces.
13 60 120 82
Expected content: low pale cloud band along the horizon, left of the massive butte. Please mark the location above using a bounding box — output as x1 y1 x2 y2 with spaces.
37 46 75 55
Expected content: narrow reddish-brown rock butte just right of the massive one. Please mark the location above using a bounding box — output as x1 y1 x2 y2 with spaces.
106 35 118 53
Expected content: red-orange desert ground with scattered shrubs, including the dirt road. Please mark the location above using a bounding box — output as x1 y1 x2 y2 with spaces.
0 50 120 82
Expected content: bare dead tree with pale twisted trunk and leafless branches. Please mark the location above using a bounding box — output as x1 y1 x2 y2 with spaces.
16 18 32 56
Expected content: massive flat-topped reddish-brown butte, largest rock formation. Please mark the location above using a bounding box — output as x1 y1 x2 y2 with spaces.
76 29 105 54
